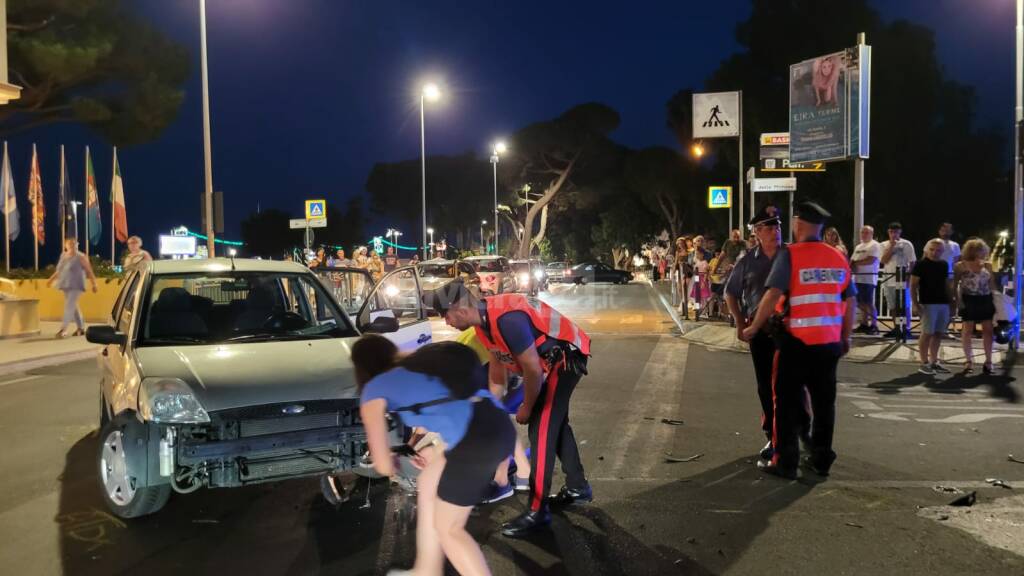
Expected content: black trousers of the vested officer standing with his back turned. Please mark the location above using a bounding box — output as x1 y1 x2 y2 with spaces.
772 334 842 469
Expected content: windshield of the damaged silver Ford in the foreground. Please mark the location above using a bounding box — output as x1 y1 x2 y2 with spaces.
138 272 357 345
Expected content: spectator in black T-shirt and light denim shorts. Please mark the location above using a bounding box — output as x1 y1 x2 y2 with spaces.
910 238 954 374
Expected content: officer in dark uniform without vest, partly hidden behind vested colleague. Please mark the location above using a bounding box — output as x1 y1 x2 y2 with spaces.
725 208 810 462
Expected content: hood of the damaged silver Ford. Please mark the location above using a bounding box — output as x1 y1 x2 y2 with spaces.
136 338 358 412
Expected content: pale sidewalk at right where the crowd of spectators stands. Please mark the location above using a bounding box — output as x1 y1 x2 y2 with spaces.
653 282 1007 366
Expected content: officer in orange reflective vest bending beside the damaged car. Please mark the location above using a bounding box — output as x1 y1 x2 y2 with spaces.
424 280 593 537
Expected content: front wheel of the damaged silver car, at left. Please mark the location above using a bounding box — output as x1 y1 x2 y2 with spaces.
96 416 171 519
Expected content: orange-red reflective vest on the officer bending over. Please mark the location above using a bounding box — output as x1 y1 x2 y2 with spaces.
476 294 590 373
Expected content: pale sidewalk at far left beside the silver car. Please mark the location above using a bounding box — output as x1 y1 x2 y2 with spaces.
0 322 100 374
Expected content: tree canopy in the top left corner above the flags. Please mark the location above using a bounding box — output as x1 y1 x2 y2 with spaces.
0 0 189 146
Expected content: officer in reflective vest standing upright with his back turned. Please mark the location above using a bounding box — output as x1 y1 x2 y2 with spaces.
743 202 857 479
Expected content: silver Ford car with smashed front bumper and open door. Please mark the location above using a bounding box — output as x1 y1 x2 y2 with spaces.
86 258 432 518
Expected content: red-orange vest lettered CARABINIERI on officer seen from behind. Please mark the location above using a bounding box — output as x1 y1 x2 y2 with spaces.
785 242 850 344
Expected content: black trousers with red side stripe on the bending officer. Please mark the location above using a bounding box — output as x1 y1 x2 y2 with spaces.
529 364 587 510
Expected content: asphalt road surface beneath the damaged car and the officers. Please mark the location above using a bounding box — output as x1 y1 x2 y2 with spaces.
0 285 1024 576
